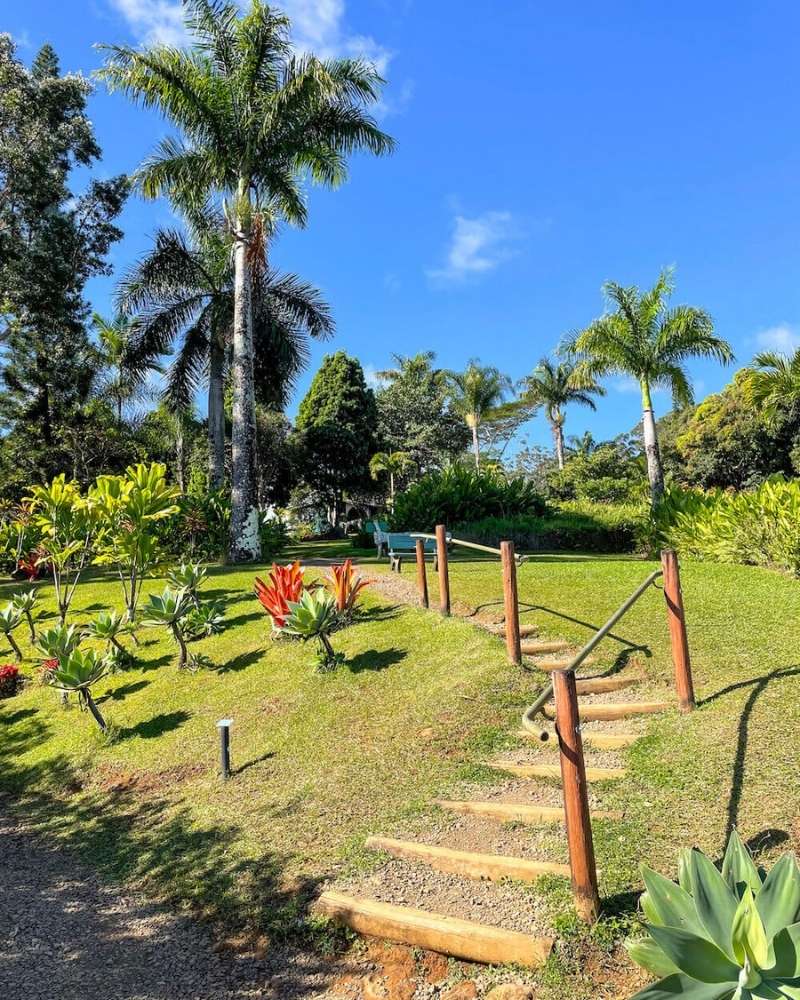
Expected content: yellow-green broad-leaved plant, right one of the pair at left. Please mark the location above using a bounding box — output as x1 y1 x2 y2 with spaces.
89 462 180 624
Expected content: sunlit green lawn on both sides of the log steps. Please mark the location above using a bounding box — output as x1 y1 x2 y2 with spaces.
0 543 800 996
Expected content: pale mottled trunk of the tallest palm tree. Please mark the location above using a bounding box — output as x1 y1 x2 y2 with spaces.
228 193 261 562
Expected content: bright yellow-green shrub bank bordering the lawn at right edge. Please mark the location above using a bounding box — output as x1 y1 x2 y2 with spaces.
653 476 800 574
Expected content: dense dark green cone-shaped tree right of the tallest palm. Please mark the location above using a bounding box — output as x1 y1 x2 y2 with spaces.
295 351 378 527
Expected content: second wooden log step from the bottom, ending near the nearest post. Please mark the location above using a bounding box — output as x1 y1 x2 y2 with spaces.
367 837 570 882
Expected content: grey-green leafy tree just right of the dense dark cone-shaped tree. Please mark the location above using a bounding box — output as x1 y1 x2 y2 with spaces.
375 351 470 473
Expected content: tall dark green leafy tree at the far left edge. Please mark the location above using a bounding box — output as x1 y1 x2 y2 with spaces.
0 35 127 481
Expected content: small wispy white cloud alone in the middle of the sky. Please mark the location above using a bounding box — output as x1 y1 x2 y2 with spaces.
427 212 519 282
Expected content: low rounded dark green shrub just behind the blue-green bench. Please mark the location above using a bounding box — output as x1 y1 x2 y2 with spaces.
392 465 546 531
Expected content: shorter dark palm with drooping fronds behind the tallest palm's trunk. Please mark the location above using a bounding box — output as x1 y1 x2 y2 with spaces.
117 212 334 489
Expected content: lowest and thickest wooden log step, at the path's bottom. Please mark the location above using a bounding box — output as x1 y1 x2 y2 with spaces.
315 891 553 969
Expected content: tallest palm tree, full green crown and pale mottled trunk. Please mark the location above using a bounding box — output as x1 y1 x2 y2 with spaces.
102 0 394 561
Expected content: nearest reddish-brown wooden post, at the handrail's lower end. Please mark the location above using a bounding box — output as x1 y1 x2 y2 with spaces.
553 670 600 923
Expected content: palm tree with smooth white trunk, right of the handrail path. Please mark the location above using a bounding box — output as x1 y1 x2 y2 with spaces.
564 269 733 504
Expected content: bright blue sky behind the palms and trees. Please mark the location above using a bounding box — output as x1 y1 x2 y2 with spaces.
6 0 800 443
